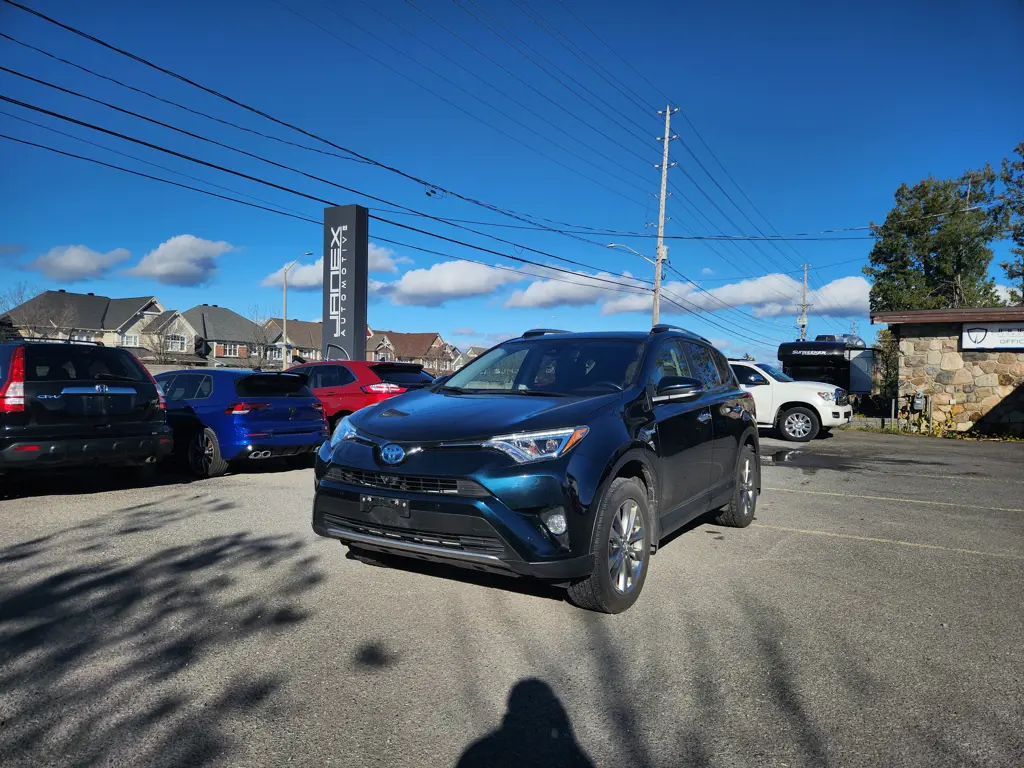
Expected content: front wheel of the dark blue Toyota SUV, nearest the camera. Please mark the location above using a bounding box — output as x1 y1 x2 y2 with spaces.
568 477 653 613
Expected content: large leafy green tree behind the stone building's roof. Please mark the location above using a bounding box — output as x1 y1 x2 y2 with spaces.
863 165 1005 311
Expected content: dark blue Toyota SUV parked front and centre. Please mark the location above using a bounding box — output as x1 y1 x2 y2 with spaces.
312 326 760 613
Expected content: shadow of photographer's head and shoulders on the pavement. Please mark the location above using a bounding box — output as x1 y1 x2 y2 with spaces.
457 678 594 768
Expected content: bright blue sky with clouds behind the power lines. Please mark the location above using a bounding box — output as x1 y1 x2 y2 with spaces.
0 0 1024 354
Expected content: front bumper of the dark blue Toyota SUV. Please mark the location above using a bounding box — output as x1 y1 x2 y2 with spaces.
312 446 593 582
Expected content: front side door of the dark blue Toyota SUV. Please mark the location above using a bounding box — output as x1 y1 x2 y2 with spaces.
648 339 713 532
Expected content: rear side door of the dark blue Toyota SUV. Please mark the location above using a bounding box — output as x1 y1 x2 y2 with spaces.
683 341 745 492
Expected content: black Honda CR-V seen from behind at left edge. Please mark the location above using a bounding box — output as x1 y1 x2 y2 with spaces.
0 340 173 474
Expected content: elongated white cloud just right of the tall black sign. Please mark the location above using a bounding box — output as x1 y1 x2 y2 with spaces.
378 261 522 306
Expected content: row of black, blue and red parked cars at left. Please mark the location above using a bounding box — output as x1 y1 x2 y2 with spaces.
0 339 433 477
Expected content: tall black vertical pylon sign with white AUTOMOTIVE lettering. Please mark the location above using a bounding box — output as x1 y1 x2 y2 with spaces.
323 206 370 360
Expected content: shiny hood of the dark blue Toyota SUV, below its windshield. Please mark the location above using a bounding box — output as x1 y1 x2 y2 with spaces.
351 389 622 442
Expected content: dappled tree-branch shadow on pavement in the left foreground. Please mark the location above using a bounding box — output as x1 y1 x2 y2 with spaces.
0 494 323 766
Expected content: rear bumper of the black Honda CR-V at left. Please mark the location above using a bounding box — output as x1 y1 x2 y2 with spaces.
0 427 174 470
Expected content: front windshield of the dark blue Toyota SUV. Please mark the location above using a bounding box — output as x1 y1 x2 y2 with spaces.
444 338 643 397
